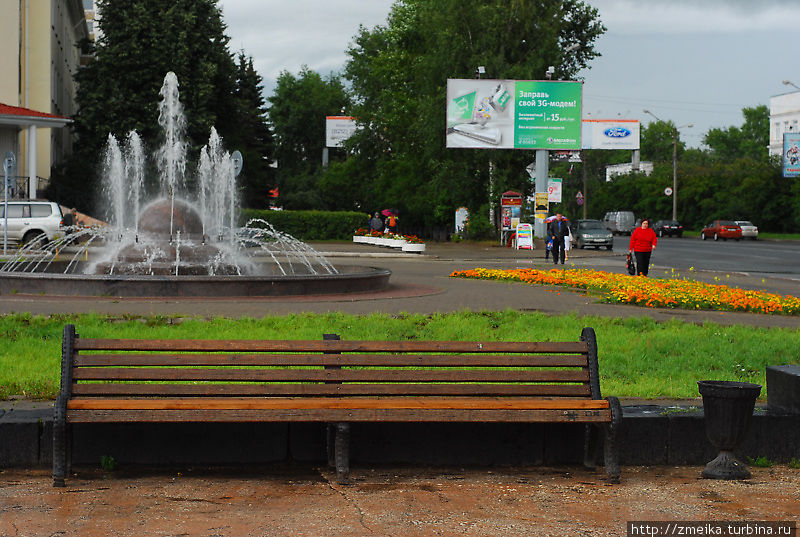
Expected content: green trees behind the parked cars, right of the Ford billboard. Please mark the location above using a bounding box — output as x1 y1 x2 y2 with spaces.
576 105 800 232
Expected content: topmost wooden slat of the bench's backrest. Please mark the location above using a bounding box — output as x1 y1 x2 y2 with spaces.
75 338 588 354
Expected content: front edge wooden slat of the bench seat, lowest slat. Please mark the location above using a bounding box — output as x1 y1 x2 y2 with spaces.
66 408 611 423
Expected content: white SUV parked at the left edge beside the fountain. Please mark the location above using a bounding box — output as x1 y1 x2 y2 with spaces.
0 200 63 244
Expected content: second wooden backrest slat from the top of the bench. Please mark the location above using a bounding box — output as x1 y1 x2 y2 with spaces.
74 354 587 367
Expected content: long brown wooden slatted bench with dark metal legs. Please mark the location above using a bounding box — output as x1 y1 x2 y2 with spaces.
53 325 622 486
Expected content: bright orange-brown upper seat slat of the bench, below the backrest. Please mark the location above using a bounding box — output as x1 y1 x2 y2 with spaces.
67 397 609 410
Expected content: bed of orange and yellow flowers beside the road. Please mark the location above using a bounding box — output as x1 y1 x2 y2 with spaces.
450 268 800 315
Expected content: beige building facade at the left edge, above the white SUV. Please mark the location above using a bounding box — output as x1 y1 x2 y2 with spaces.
0 0 89 197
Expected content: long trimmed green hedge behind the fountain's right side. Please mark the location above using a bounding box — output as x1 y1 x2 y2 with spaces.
239 209 369 241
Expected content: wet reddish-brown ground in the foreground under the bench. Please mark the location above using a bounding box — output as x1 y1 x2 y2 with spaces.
0 466 800 537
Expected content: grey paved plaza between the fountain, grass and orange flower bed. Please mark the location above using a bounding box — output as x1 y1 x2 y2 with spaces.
0 242 800 327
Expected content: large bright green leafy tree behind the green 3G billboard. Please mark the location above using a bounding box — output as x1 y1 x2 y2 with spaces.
335 0 605 225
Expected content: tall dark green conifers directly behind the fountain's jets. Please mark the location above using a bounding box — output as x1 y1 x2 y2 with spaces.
57 0 267 213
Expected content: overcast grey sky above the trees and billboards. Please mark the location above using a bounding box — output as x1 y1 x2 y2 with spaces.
221 0 800 147
